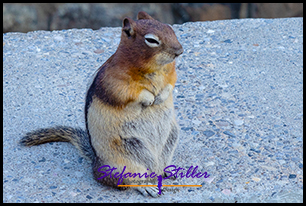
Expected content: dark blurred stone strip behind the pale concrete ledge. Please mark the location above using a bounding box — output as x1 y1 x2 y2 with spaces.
3 3 303 33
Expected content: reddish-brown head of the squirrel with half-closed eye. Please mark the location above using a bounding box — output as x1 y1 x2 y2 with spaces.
118 12 183 65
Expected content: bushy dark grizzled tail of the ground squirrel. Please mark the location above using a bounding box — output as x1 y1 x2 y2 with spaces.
20 126 95 162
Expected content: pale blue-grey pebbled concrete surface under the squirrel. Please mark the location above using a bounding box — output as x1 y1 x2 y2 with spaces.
3 18 303 203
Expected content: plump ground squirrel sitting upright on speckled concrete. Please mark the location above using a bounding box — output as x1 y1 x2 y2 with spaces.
21 12 183 197
